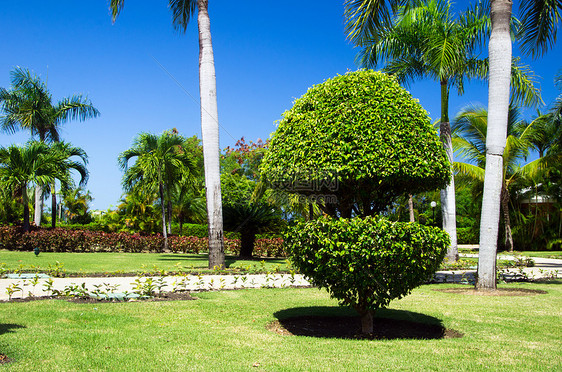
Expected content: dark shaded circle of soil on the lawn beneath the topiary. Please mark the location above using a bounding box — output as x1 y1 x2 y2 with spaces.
268 307 463 340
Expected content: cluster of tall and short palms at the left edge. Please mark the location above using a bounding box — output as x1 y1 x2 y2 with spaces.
0 67 99 230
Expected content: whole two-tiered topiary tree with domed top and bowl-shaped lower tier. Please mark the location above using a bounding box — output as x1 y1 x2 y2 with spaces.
261 70 450 333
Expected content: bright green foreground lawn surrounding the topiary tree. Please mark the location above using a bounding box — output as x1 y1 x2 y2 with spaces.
0 281 562 371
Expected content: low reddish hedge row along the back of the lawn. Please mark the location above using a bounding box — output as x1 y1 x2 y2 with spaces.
0 226 284 257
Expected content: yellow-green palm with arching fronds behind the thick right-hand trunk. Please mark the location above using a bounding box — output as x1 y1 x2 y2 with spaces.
453 93 562 251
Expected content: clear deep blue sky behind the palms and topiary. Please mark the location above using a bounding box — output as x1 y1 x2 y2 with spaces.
0 0 562 209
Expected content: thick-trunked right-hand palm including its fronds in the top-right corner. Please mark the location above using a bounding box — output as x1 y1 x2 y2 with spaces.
476 0 562 290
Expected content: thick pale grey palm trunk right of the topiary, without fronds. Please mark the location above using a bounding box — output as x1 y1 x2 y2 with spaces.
476 0 512 290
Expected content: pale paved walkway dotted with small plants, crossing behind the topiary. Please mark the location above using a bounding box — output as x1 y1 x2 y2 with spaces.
0 255 562 300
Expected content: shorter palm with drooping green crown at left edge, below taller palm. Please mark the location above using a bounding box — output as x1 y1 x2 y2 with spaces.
0 141 72 232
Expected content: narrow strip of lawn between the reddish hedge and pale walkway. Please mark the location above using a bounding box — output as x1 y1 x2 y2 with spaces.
0 250 288 274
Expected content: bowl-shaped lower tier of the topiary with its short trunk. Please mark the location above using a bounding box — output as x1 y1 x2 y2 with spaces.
285 217 449 333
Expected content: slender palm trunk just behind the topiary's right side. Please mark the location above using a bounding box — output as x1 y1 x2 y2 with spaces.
439 79 459 262
